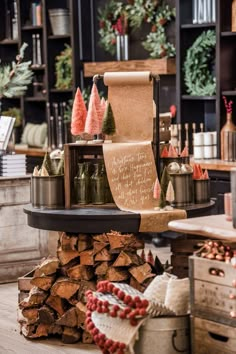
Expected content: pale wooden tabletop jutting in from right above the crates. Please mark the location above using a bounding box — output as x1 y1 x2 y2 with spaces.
168 214 236 241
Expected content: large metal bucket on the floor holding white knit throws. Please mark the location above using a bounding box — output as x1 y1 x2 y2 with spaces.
134 316 190 354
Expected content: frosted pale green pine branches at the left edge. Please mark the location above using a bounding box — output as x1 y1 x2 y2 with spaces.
0 43 33 99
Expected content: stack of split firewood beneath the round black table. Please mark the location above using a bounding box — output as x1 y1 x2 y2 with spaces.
18 231 156 343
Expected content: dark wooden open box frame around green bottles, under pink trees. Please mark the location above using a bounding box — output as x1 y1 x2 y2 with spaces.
64 143 103 209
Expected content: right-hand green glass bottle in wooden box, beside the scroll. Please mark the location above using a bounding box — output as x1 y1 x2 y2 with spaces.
91 163 105 204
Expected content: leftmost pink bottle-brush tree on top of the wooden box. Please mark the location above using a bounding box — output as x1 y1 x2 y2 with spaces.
71 87 87 135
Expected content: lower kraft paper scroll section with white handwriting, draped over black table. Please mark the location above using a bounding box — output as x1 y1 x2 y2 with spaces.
103 141 186 232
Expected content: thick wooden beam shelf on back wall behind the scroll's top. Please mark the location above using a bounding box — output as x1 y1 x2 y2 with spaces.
84 58 176 77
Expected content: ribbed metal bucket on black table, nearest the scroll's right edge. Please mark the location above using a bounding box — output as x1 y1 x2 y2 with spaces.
170 172 193 207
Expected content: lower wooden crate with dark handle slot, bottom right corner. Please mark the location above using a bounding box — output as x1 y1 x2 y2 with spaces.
191 316 236 354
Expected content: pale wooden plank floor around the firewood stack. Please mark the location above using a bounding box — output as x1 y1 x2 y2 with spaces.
0 245 170 354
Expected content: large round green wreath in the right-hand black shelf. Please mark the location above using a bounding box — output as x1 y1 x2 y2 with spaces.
183 30 216 96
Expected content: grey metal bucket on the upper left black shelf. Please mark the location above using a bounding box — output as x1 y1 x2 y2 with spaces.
48 9 70 35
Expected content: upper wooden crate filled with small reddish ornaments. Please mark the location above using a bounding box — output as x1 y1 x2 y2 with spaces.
189 256 236 327
